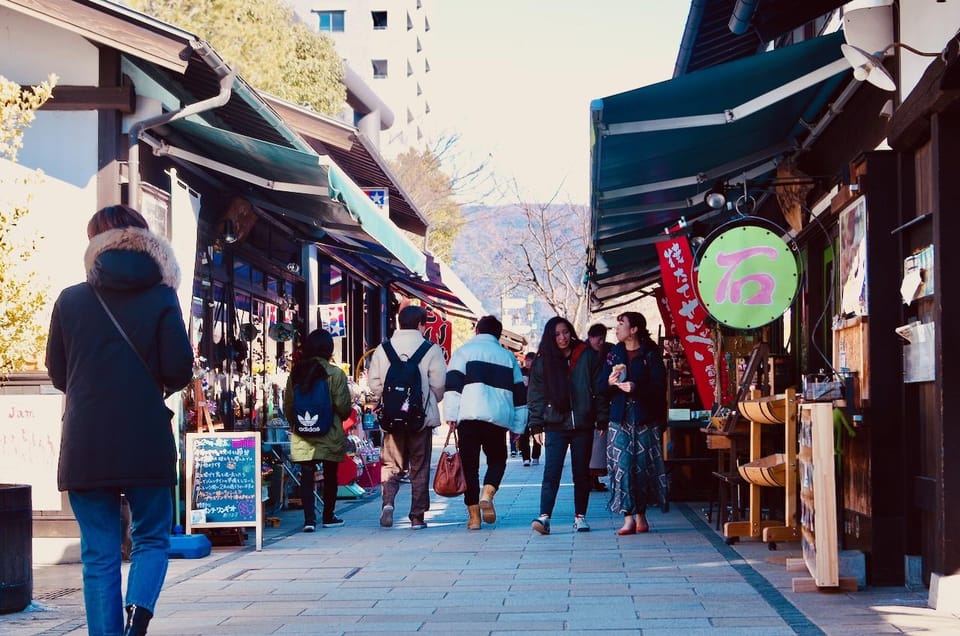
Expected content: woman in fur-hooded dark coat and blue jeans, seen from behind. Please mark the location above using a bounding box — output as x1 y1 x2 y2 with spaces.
46 205 193 634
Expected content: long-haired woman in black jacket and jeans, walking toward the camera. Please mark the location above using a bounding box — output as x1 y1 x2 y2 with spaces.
527 316 607 534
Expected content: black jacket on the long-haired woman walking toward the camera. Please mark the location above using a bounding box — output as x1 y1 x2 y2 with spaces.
527 343 608 433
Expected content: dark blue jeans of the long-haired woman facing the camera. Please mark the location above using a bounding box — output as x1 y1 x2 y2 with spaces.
540 428 593 515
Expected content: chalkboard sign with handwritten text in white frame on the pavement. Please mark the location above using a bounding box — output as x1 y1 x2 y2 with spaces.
186 433 263 550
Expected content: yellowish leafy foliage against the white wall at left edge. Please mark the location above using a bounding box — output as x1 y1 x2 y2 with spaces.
0 75 57 378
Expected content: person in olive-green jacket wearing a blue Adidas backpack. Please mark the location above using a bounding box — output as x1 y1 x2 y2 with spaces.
283 329 353 532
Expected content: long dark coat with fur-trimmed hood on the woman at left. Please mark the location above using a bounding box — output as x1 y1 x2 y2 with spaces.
46 228 193 490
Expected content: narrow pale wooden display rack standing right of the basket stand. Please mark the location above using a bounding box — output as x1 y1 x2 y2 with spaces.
786 402 857 592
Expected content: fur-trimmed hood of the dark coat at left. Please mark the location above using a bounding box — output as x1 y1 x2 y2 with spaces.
83 227 180 289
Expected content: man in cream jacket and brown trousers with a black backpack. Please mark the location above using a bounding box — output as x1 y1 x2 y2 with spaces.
367 305 447 530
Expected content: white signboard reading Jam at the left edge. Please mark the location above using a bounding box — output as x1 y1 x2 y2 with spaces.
0 392 63 510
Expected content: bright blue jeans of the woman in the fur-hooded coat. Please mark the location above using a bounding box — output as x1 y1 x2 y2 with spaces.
69 486 173 636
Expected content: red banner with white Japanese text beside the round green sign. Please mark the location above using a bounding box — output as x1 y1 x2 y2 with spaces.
657 235 717 409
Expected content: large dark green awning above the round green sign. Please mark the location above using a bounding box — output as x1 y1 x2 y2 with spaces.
588 32 851 307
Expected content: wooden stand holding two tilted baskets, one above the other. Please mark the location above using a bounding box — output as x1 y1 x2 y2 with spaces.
723 389 800 550
